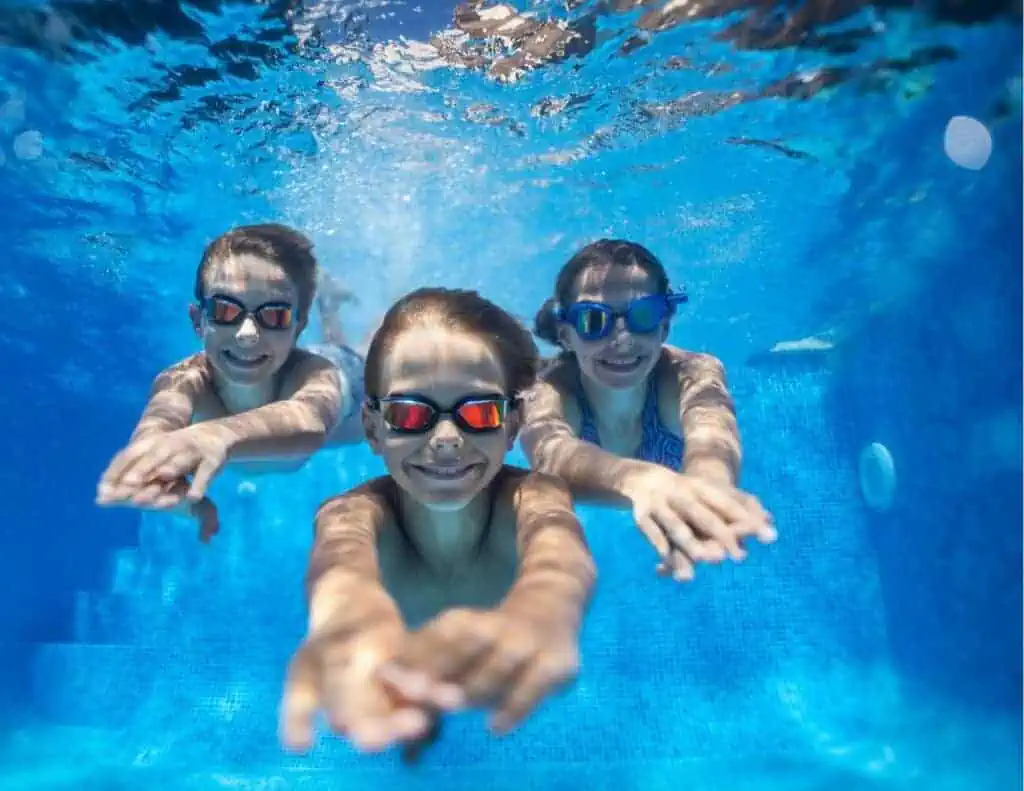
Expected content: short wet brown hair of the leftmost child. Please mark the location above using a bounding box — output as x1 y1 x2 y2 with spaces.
196 222 317 318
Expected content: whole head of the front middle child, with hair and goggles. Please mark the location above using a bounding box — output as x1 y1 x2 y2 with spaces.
364 288 538 510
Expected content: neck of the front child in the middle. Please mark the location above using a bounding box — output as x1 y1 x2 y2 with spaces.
398 486 492 577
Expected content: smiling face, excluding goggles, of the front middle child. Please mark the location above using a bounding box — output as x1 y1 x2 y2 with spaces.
364 329 515 510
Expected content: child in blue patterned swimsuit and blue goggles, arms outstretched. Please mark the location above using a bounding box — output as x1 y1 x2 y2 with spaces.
522 239 775 580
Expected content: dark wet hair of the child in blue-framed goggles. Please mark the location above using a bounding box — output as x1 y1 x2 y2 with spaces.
534 239 669 346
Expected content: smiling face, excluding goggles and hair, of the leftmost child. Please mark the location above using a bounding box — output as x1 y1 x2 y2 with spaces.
191 253 302 385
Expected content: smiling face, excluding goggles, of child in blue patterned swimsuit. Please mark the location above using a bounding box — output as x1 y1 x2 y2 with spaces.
558 266 669 389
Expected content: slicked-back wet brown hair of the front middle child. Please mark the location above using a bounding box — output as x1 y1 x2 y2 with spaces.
366 288 540 398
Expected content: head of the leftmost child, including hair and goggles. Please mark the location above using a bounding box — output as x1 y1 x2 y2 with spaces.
189 223 316 384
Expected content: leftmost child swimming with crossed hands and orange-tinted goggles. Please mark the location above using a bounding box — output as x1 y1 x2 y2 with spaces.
96 224 362 538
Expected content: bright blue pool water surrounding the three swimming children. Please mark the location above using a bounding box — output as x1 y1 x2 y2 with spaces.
0 0 1022 791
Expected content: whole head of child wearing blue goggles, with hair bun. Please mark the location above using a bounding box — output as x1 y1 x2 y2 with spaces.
534 239 686 388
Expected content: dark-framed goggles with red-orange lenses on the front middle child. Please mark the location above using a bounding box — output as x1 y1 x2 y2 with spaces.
367 394 514 434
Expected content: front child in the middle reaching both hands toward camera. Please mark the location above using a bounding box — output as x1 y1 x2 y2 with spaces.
281 288 595 751
